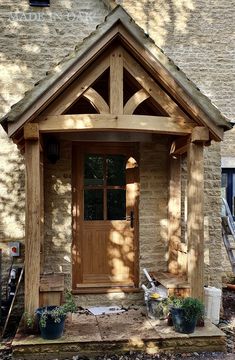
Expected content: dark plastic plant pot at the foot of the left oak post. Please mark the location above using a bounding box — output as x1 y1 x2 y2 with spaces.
36 306 66 340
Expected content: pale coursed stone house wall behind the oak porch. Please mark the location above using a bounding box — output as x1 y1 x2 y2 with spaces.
0 0 235 304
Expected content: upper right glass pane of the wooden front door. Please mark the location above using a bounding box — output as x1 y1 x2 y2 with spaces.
107 155 126 186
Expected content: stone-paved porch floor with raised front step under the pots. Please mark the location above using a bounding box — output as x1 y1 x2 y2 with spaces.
12 308 225 360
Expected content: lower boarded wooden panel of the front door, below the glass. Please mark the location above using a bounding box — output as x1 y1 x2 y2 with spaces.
82 221 134 285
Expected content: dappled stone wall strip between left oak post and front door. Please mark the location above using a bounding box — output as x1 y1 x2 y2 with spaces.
42 141 72 287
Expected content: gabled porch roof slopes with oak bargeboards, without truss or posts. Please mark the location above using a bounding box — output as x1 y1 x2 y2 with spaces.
1 6 231 141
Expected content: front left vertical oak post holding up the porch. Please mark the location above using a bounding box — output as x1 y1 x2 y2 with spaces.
24 124 41 315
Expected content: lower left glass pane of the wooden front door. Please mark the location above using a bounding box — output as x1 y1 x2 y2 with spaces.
84 190 104 220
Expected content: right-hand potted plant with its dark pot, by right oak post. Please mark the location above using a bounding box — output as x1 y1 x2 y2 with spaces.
170 297 204 334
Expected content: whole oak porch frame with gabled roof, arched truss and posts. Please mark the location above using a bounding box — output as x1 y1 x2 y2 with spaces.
1 7 230 313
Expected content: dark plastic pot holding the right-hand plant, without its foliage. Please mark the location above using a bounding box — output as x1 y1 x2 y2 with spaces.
171 308 197 334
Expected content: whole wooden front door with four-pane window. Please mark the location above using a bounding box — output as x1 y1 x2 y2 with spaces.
72 143 139 292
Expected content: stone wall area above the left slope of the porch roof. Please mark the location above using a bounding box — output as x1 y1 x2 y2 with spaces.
0 0 107 115
